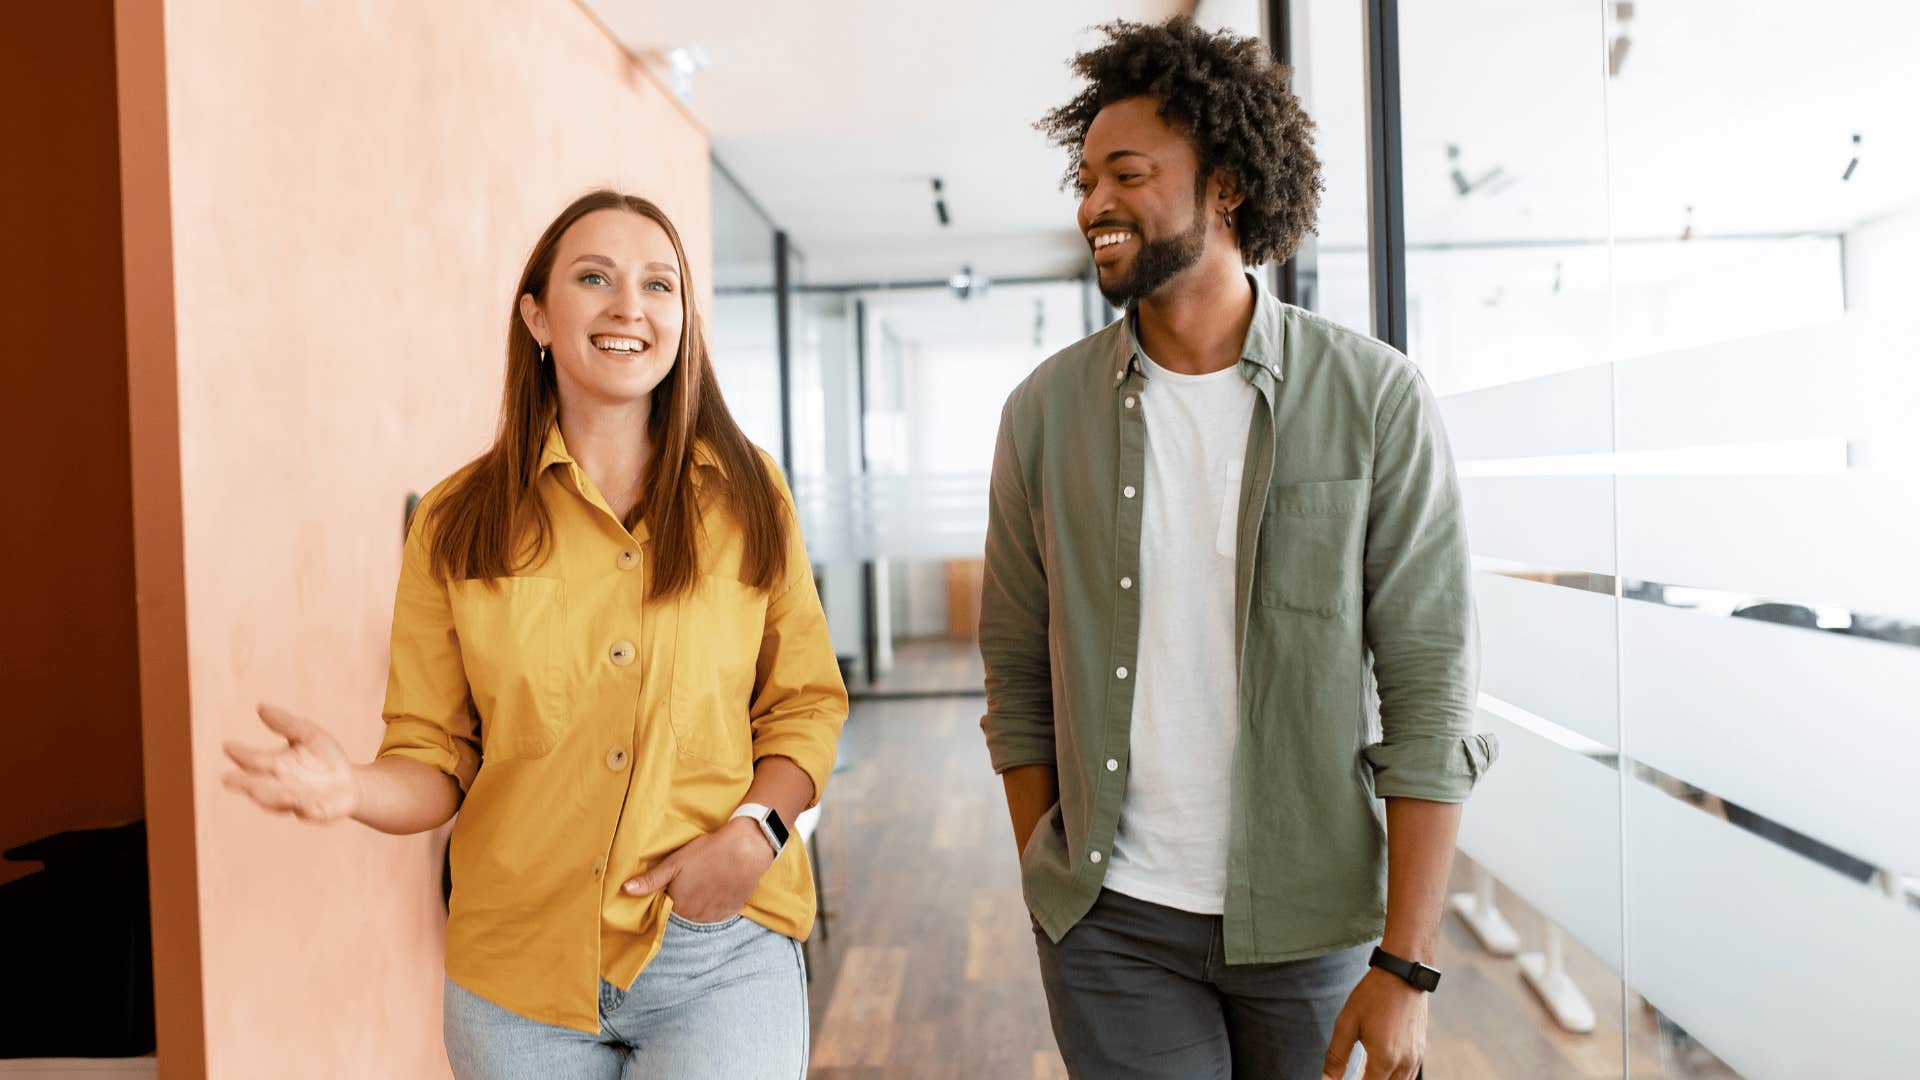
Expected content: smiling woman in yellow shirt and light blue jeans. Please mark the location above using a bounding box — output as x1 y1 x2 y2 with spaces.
227 190 847 1078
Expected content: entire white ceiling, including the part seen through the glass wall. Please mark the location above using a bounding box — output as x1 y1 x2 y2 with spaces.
589 0 1920 282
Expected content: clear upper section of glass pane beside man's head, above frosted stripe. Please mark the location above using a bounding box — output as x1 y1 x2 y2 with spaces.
1400 2 1611 394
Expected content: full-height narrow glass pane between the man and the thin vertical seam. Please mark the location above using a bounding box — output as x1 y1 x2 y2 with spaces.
1397 0 1620 1080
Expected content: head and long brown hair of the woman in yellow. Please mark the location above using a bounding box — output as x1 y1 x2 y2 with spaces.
432 190 787 598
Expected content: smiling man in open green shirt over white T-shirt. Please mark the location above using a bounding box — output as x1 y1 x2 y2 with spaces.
979 19 1496 1080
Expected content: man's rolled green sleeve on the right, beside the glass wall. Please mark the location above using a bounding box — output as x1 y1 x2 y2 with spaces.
1365 365 1500 803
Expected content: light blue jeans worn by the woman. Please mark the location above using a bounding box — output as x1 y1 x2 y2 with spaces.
445 915 806 1080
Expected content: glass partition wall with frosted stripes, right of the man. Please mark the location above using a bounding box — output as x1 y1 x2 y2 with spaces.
1320 0 1920 1078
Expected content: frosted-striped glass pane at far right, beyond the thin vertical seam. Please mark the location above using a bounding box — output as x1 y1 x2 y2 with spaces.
1605 0 1920 1076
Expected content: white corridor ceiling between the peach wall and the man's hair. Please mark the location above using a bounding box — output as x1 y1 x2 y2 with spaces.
589 0 1185 282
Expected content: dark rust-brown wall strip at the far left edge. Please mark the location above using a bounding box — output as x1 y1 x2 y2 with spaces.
0 0 142 880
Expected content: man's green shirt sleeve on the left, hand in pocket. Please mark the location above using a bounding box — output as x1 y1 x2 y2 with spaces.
979 400 1056 773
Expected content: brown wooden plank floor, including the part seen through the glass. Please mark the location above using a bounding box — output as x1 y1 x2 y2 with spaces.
810 644 1736 1080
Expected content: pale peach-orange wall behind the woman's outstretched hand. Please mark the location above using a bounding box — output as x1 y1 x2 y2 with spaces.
121 0 712 1078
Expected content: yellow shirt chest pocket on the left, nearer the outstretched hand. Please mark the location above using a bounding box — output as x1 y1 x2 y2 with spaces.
447 577 568 761
